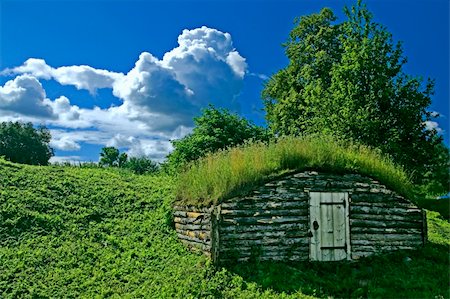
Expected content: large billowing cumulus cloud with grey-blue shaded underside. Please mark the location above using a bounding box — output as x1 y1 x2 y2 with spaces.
113 27 247 132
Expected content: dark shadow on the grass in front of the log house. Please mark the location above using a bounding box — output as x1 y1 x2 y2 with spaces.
227 243 450 298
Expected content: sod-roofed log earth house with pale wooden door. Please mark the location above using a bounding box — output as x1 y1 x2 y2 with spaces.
174 140 427 263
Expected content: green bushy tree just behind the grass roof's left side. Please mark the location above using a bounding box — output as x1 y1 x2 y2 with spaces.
166 105 268 169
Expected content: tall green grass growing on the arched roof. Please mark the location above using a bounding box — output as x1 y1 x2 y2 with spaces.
177 136 412 206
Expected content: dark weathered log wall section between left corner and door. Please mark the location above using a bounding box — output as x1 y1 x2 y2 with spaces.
218 198 308 262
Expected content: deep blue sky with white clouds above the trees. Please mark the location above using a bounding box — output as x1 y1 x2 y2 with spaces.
0 0 449 161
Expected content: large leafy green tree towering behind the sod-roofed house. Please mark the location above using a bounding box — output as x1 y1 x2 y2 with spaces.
262 1 448 195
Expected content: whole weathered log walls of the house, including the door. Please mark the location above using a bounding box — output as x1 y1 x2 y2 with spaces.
174 171 427 262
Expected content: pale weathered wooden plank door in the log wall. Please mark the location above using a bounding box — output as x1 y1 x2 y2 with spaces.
309 192 350 261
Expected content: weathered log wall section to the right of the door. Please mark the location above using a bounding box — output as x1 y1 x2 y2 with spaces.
350 192 426 259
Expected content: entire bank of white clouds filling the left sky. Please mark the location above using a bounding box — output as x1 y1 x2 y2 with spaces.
0 26 248 160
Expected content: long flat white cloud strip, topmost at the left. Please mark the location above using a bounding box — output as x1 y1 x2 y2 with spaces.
2 58 123 93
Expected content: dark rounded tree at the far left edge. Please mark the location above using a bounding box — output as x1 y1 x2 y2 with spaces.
0 122 53 165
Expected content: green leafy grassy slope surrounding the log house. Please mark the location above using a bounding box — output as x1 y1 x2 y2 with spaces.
0 161 450 298
